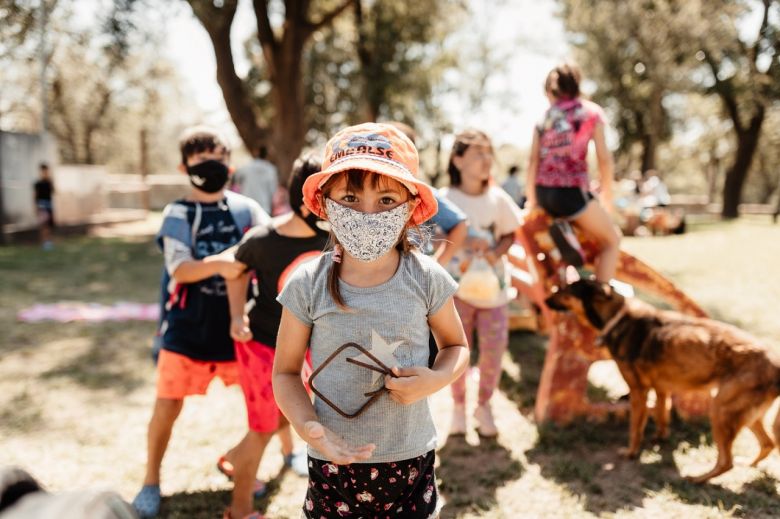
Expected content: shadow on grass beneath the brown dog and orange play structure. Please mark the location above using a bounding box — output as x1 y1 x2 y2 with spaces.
501 333 780 517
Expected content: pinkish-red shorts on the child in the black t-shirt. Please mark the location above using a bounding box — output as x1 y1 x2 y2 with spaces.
234 340 311 433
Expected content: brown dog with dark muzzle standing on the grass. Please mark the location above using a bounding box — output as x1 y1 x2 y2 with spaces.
547 280 780 483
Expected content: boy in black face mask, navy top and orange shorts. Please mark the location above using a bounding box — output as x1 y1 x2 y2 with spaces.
133 127 269 517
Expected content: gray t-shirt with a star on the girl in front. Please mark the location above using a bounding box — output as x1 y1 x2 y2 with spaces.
277 252 457 463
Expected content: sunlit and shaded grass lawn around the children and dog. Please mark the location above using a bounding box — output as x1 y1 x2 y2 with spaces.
0 220 780 519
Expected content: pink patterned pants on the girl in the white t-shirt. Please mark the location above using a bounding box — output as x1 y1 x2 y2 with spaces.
452 297 509 405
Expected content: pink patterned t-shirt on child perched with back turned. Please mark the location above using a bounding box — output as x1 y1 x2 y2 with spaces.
536 99 606 189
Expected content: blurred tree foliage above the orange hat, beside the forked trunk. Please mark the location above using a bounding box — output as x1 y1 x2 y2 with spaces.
245 0 455 144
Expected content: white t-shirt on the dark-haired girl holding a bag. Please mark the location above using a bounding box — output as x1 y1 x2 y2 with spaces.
440 186 522 308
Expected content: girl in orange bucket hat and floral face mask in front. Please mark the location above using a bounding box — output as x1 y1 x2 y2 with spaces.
273 123 468 518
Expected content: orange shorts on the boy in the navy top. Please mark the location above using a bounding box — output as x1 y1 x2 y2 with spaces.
157 349 239 400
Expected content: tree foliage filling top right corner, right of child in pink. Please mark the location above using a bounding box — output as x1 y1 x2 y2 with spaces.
560 0 780 209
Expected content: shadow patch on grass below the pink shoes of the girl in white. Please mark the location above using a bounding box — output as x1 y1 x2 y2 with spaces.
436 436 524 518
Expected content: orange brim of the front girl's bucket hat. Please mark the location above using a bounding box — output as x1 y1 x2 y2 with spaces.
303 157 439 225
